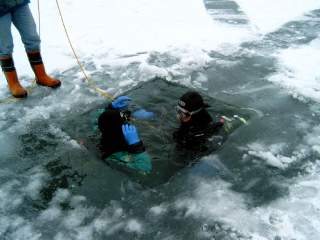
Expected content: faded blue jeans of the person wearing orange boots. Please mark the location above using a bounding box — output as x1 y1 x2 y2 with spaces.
0 4 40 57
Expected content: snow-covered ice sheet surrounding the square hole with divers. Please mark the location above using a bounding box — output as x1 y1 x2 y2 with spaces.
0 0 320 240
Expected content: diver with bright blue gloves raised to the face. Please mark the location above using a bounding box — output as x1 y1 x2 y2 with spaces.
98 96 154 175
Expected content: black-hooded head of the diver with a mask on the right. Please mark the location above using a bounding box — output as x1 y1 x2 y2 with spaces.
176 91 208 123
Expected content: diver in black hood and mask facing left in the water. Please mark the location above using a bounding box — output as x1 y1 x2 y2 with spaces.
173 91 224 152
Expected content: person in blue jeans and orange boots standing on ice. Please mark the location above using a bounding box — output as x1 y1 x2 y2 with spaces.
0 0 61 98
